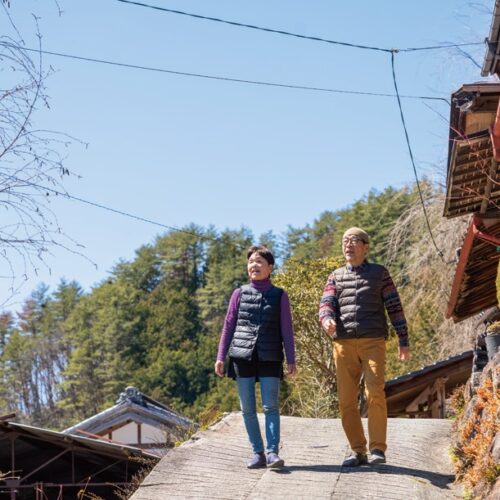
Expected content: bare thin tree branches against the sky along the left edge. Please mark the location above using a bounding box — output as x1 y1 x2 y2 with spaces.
0 15 89 305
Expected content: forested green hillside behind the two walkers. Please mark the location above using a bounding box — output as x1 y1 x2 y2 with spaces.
0 185 467 429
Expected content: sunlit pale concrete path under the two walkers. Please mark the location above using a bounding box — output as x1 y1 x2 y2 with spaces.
131 413 461 500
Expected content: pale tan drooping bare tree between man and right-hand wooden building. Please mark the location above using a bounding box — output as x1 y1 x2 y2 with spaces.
388 189 477 361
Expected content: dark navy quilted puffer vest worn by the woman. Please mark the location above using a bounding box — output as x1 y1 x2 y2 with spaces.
229 285 284 361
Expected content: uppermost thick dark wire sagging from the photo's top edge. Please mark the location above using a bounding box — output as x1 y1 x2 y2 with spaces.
116 0 484 53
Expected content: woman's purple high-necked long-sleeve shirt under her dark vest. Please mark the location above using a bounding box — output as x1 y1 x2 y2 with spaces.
217 279 295 365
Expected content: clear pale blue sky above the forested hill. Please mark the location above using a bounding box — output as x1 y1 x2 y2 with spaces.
0 0 493 307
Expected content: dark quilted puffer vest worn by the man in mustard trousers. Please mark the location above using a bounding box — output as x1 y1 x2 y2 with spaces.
333 262 388 339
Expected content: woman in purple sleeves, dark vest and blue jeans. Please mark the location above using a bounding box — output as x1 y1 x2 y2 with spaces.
215 245 296 469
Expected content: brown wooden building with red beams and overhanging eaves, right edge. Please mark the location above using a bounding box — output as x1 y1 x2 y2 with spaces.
444 83 500 322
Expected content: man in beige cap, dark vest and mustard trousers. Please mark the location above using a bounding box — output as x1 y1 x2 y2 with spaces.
319 227 410 467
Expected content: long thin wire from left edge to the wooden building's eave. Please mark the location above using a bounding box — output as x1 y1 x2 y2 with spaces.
0 42 448 103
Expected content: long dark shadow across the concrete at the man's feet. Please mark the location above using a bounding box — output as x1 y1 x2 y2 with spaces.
274 464 455 489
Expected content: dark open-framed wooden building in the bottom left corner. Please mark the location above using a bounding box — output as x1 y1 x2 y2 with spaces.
0 415 159 500
